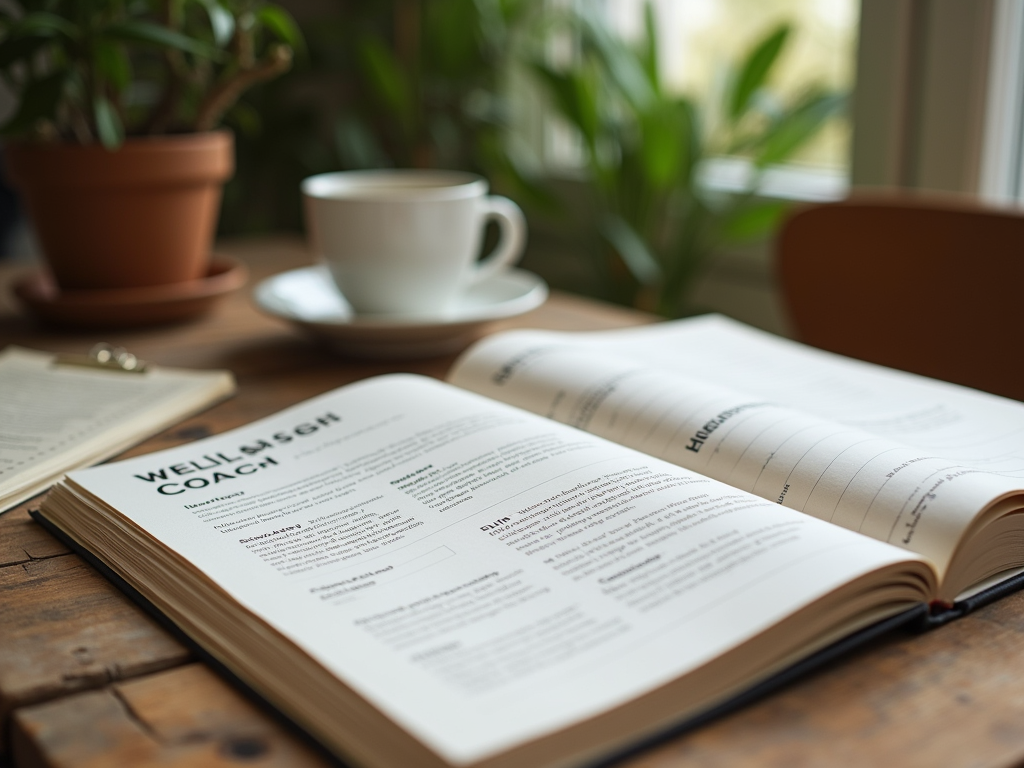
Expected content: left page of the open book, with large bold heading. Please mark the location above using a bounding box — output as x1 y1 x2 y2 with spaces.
59 376 934 764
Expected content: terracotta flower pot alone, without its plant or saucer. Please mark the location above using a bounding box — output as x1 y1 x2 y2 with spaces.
5 131 234 291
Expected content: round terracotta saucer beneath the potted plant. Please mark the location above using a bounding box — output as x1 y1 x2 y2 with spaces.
13 255 249 328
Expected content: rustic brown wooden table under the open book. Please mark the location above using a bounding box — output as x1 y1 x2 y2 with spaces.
0 239 1024 768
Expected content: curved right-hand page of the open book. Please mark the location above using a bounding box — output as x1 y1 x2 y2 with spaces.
451 316 1024 586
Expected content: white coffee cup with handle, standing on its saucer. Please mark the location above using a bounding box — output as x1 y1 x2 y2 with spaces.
302 170 526 316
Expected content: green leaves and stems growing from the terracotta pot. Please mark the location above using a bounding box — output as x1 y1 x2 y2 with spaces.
0 0 302 148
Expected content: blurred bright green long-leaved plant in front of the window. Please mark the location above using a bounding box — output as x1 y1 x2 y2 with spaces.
532 5 845 317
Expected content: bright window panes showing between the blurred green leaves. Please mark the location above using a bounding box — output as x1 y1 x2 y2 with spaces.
543 0 860 201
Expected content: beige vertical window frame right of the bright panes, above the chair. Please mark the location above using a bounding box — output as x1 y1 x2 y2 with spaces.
850 0 995 195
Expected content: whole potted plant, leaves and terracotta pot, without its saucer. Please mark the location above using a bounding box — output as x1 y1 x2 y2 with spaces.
0 0 301 317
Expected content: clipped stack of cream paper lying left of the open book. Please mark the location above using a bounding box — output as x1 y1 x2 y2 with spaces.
0 346 234 511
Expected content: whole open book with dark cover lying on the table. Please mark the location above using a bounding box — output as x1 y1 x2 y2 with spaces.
42 317 1024 768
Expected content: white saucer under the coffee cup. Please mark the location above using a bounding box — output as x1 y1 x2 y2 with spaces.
253 266 548 359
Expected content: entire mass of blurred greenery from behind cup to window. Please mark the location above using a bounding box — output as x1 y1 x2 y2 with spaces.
221 0 845 316
